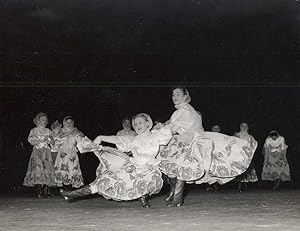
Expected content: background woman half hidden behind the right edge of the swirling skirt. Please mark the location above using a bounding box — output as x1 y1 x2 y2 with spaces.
234 122 258 192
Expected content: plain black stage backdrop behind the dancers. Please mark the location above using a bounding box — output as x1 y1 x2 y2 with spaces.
0 0 300 188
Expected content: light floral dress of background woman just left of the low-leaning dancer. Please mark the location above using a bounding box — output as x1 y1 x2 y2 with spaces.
54 128 83 188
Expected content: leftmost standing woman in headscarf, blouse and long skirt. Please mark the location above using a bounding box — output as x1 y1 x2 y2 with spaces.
23 112 55 198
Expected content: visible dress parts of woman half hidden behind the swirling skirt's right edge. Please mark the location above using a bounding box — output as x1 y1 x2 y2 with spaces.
234 132 258 183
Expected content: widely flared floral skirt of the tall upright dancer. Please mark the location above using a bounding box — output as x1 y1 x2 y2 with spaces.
157 132 256 184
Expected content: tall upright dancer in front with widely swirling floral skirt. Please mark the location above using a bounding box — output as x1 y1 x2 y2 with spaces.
156 87 256 207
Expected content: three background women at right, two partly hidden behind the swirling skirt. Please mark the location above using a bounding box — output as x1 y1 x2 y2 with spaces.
207 122 291 192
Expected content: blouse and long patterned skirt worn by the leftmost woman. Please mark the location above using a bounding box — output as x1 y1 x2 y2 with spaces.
23 127 55 187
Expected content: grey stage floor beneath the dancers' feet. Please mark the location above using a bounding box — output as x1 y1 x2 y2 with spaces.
0 189 300 231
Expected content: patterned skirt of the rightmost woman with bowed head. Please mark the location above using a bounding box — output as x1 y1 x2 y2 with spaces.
262 150 291 181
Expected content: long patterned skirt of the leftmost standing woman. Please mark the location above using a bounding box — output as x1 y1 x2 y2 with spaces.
23 148 55 187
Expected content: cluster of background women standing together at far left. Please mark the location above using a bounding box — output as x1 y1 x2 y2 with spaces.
23 112 84 198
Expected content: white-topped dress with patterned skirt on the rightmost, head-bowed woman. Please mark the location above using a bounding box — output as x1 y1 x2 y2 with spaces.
262 136 291 181
